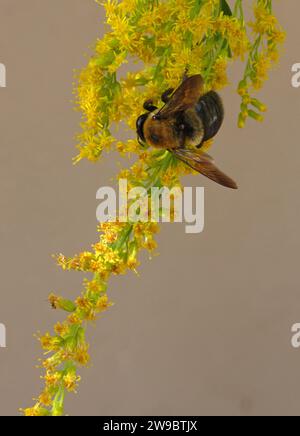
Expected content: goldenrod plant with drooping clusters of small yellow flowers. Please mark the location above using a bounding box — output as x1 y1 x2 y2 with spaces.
23 0 284 416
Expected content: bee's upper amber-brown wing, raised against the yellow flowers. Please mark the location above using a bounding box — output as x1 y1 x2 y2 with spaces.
159 74 204 118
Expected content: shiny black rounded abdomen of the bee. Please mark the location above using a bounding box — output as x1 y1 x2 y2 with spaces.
196 91 224 145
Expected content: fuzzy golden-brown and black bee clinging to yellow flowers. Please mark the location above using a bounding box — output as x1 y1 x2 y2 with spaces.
136 74 237 189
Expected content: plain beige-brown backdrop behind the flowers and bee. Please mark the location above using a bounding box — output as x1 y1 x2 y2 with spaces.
0 0 300 415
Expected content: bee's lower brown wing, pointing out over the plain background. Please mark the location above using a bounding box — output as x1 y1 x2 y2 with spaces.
170 148 238 189
